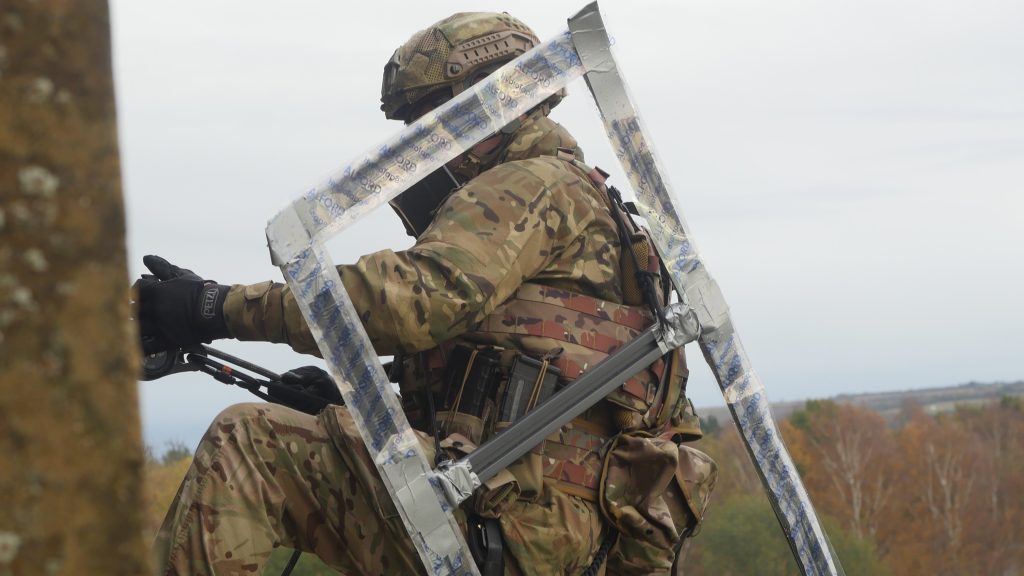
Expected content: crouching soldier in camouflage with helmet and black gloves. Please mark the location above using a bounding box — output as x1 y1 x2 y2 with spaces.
136 13 715 575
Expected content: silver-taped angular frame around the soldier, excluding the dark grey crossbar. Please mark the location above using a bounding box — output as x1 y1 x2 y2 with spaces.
267 3 838 574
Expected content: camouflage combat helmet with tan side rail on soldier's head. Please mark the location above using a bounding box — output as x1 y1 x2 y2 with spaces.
381 12 540 122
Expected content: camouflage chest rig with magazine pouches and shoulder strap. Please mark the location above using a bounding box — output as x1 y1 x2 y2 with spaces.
392 149 701 499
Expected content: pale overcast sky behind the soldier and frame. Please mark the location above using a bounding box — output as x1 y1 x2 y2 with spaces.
112 0 1024 451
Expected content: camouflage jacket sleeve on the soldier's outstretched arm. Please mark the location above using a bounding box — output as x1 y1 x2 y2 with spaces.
224 158 601 355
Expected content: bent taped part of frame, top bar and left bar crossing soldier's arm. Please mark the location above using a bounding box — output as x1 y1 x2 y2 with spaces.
266 24 584 575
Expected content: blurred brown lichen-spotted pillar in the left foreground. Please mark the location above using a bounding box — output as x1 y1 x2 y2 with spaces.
0 0 148 576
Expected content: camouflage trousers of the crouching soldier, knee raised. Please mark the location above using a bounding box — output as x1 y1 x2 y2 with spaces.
155 404 603 576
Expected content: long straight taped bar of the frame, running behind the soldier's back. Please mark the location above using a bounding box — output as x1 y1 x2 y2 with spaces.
569 3 841 574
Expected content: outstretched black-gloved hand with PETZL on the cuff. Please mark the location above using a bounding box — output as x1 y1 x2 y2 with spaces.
132 256 230 354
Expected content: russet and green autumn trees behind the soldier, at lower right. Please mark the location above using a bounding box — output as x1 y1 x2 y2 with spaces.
687 398 1024 576
